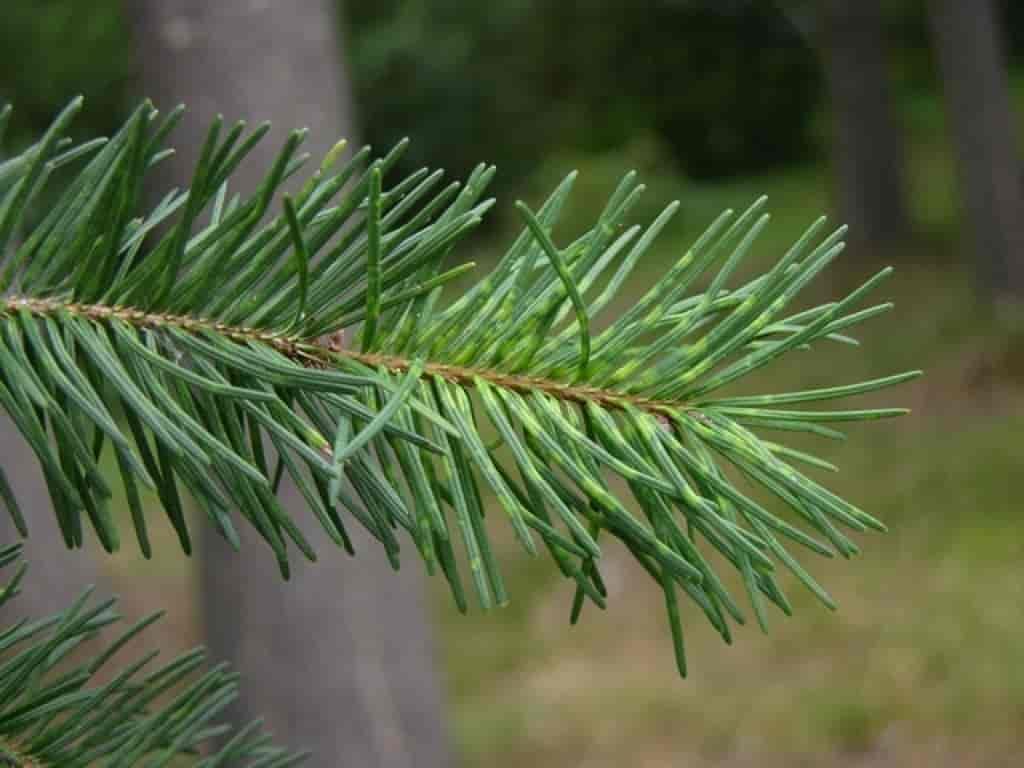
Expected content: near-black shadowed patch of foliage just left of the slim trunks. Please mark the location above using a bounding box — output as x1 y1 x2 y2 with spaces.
638 0 821 177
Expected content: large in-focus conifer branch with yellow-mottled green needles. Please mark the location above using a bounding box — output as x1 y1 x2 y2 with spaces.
0 97 916 670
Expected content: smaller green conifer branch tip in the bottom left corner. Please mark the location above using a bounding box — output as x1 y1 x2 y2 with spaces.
0 545 305 768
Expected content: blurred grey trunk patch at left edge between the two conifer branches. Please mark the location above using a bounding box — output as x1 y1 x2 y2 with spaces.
0 416 102 629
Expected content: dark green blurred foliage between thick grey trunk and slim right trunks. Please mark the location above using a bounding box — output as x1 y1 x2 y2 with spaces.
344 0 820 183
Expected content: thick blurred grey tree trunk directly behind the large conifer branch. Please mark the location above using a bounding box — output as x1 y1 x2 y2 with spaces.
129 0 449 768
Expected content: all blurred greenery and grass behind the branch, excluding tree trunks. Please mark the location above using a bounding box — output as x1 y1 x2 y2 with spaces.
0 0 1024 768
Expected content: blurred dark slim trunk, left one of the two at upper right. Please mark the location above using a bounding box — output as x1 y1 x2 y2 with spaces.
818 0 908 259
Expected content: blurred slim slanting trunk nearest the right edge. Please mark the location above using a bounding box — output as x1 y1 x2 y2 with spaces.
930 0 1024 302
